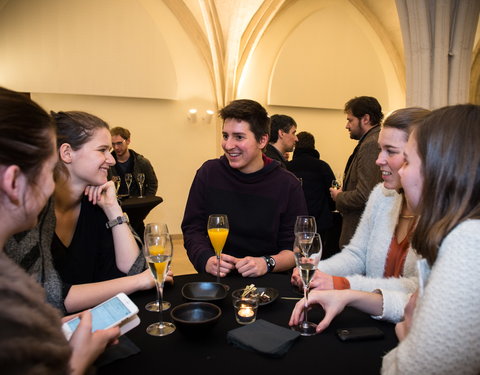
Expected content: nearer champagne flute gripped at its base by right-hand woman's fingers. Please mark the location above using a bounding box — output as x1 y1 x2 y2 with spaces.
292 233 322 336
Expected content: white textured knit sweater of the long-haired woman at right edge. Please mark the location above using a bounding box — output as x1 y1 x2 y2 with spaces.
382 220 480 375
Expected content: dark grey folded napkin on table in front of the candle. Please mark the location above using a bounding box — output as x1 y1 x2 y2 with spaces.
227 319 300 357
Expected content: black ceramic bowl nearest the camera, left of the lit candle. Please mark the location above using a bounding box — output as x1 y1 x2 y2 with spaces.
170 302 222 334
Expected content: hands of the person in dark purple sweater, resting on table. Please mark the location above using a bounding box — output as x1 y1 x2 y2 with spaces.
205 254 267 277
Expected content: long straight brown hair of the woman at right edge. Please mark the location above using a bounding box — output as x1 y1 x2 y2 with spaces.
412 104 480 265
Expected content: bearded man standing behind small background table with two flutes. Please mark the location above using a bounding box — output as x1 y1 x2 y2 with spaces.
109 127 158 197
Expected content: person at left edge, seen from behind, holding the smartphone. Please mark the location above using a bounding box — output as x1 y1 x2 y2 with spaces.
0 88 120 375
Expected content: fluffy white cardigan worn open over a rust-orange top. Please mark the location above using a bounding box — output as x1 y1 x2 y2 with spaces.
318 183 418 322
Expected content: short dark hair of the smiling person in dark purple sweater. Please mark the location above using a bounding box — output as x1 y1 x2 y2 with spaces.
219 99 270 142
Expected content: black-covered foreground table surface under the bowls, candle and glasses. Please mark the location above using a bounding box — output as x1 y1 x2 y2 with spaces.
97 273 398 375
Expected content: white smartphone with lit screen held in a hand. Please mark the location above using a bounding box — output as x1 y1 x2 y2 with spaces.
62 293 140 340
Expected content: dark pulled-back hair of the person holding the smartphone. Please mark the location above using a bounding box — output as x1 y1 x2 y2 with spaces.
0 87 55 182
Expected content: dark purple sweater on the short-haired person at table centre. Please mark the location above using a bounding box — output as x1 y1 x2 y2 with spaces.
182 156 307 272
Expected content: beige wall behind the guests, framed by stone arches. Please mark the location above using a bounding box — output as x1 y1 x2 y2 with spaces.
0 0 404 233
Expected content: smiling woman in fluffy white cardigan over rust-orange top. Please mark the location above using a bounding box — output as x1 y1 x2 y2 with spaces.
293 107 430 322
